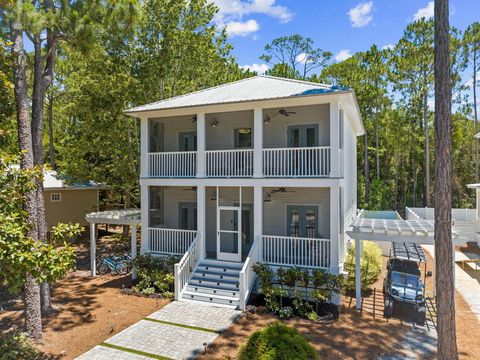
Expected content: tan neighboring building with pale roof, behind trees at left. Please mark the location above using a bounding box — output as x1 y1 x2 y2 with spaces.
43 170 102 230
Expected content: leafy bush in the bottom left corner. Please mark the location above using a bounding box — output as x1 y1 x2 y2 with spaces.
0 331 55 360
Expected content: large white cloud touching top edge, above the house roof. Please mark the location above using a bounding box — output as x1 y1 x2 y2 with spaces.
212 0 293 24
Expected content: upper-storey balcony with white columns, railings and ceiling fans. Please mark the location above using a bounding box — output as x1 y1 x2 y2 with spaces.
142 104 344 178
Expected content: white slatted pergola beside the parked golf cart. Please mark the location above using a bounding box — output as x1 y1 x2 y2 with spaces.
346 214 467 310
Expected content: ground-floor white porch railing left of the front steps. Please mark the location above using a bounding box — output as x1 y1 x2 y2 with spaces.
148 228 197 255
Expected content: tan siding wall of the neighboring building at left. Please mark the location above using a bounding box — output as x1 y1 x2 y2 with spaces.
44 189 98 229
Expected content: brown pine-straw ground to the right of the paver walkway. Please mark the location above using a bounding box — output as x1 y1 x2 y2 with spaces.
199 253 480 360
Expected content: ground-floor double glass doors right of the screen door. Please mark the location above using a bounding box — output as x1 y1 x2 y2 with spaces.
287 205 318 238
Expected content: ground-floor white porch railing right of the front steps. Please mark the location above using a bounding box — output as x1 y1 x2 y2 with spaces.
262 235 330 269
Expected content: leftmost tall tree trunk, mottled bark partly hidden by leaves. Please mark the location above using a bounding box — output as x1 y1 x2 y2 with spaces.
10 4 42 339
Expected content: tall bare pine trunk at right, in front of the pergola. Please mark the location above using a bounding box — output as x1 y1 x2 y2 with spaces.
434 0 458 360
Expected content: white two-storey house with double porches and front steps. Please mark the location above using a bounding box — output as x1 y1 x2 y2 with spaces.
126 76 364 308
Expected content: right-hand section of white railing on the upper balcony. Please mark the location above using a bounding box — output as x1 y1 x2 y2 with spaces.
263 146 330 177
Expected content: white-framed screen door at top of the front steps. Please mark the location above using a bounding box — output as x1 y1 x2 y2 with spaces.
217 206 242 262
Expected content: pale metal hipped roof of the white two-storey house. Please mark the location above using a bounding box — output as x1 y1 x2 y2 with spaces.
125 75 353 114
